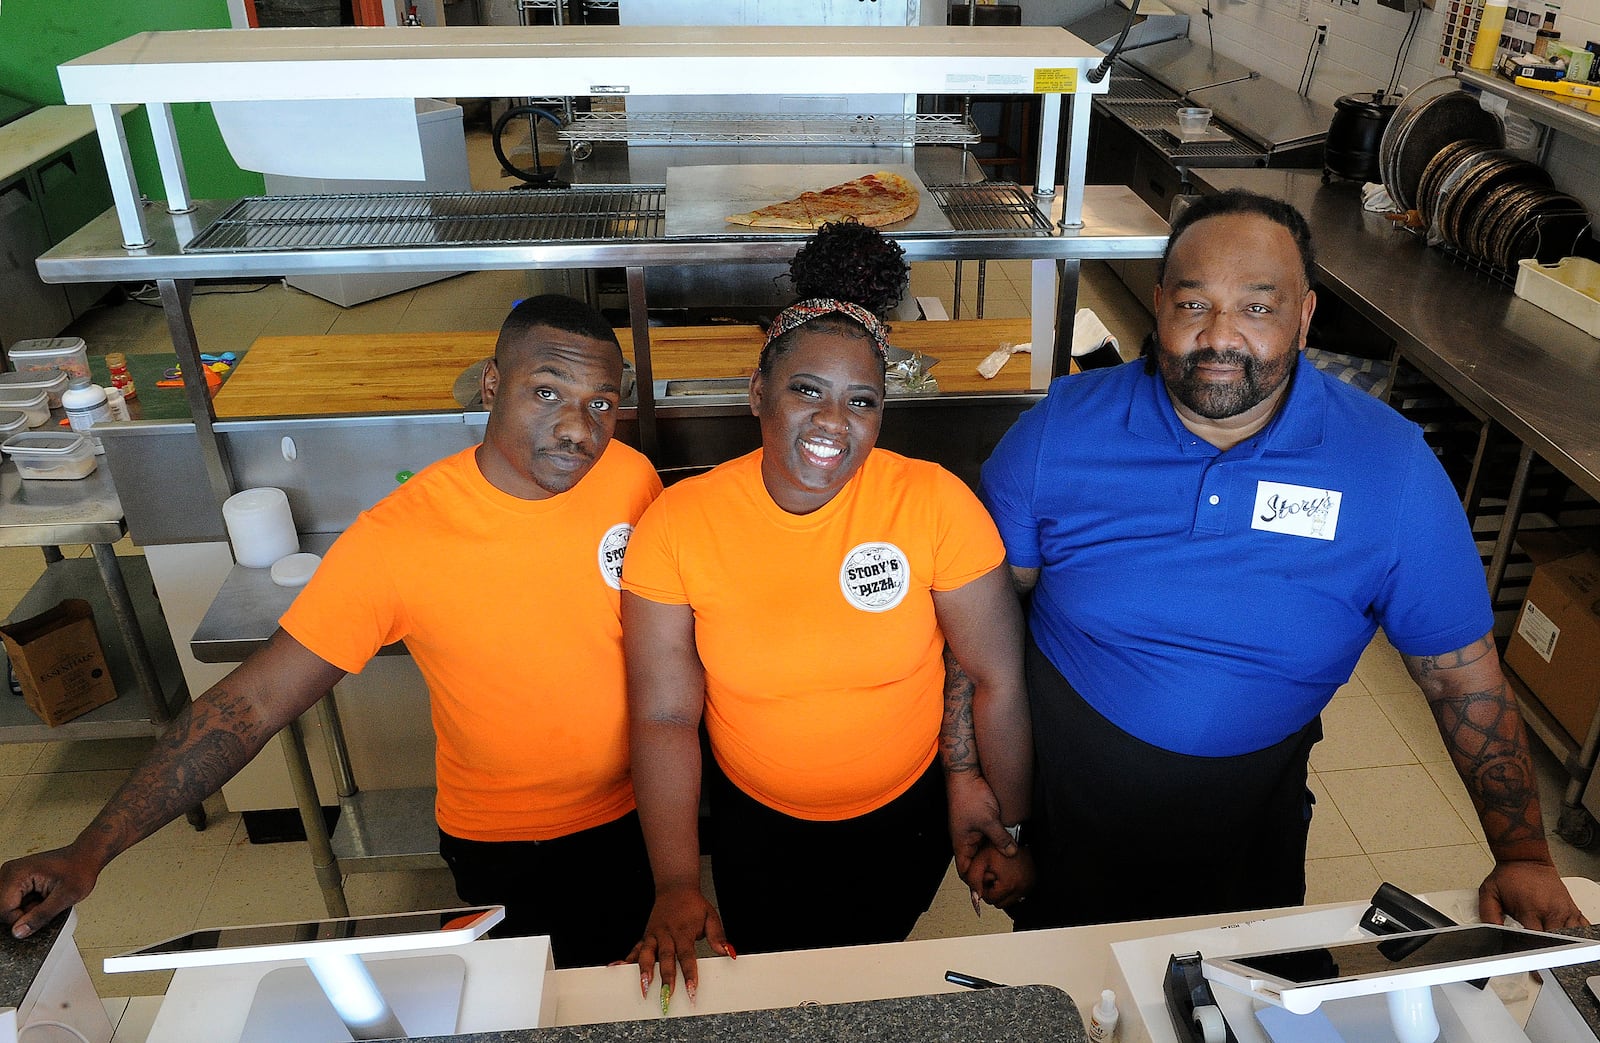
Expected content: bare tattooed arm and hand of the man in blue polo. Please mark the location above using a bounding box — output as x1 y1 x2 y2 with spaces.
1403 633 1586 929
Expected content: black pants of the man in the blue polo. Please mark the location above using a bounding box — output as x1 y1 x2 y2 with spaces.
1013 638 1322 928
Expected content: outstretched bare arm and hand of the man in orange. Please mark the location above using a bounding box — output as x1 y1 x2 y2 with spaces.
0 630 344 937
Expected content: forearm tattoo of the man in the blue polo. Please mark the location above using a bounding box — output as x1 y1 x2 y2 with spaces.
1406 640 1544 853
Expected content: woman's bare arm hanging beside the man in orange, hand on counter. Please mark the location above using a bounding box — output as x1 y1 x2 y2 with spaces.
622 590 731 1000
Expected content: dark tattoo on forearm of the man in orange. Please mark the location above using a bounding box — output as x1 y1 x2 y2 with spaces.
91 689 270 848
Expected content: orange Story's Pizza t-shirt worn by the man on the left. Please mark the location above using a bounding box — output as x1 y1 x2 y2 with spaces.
280 442 661 840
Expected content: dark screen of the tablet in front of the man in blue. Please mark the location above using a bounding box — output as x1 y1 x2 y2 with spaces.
1230 926 1582 985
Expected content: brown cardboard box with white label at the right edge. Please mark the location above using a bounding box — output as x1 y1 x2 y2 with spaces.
1506 550 1600 742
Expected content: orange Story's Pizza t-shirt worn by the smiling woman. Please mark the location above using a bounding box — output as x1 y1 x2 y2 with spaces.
622 450 1005 821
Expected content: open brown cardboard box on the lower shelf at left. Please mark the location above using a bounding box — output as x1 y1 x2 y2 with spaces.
0 598 117 728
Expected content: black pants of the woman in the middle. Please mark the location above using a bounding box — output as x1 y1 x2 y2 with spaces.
706 758 950 953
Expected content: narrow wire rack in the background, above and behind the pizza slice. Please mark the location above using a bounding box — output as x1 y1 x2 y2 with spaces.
560 112 981 146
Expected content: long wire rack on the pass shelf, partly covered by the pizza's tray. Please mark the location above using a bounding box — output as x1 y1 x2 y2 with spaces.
184 182 1053 254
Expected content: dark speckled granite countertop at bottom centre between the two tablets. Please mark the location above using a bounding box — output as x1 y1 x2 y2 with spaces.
400 985 1088 1043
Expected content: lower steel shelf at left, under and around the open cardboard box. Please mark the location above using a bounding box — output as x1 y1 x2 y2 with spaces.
0 557 189 742
